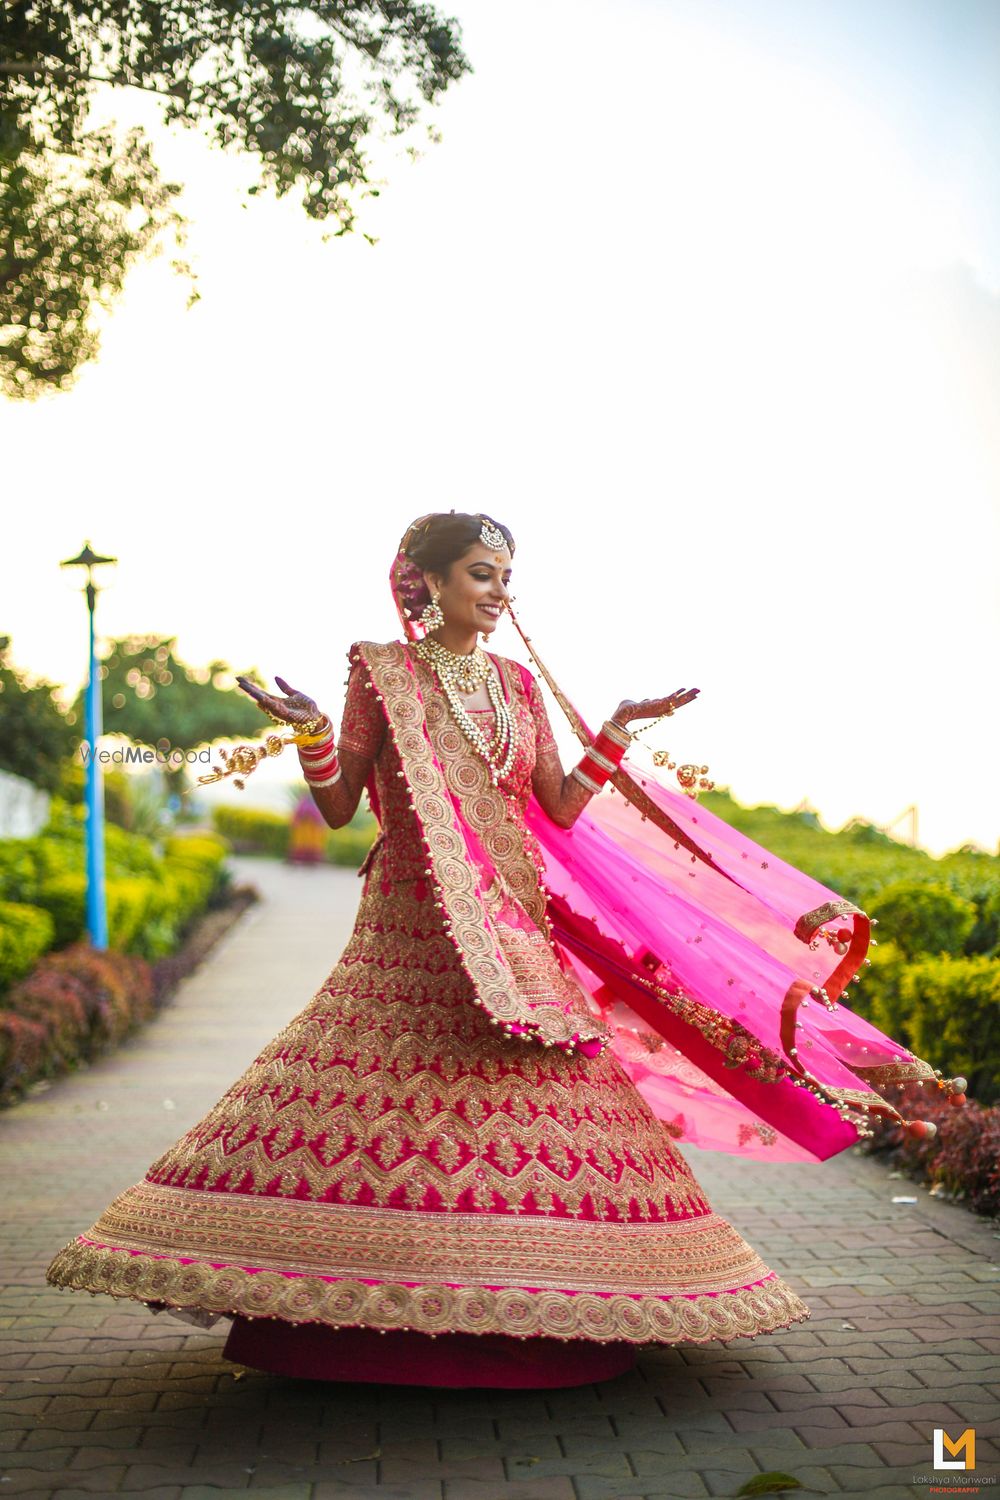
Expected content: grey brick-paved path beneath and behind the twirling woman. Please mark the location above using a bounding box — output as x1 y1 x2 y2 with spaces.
0 861 1000 1500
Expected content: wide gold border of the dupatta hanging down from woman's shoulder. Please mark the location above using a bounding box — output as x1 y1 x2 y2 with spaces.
357 641 610 1047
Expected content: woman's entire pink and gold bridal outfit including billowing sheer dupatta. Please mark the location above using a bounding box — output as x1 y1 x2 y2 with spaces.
48 642 953 1388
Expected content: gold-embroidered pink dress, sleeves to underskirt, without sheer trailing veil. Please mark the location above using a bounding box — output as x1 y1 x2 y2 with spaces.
48 647 808 1388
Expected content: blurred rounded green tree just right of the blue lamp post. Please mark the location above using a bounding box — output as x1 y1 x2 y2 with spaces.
73 636 267 770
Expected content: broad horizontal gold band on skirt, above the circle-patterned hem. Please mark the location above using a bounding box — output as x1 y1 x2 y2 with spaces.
56 1181 771 1296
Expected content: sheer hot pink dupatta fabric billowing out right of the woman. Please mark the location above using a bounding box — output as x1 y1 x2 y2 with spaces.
528 773 937 1161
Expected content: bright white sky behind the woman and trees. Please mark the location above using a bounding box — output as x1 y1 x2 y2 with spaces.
0 0 1000 854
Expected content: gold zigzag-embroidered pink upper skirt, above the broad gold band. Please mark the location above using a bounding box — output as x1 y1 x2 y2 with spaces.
134 860 708 1221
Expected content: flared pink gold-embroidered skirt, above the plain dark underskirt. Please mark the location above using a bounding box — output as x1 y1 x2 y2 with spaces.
48 861 808 1344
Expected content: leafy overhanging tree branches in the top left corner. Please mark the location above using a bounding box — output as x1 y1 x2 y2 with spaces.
0 0 469 396
